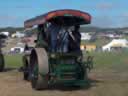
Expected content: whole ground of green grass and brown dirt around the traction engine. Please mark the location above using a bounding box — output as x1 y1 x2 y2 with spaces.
0 51 128 96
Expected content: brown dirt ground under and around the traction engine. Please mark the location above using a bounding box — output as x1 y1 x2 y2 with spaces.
0 70 128 96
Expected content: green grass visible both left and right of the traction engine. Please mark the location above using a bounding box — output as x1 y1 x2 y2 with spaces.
4 51 128 72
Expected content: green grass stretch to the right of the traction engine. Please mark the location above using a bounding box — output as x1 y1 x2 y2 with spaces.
83 51 128 72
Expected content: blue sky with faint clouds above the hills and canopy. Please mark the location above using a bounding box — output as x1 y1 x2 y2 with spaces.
0 0 128 28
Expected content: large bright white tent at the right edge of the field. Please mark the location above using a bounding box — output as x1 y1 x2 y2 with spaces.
102 39 128 51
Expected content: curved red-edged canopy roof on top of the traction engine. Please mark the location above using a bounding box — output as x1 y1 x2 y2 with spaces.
24 9 91 27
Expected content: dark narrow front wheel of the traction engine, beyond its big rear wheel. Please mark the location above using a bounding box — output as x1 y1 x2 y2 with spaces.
23 56 30 80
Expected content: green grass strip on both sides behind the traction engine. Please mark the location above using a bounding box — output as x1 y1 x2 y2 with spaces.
4 51 128 67
